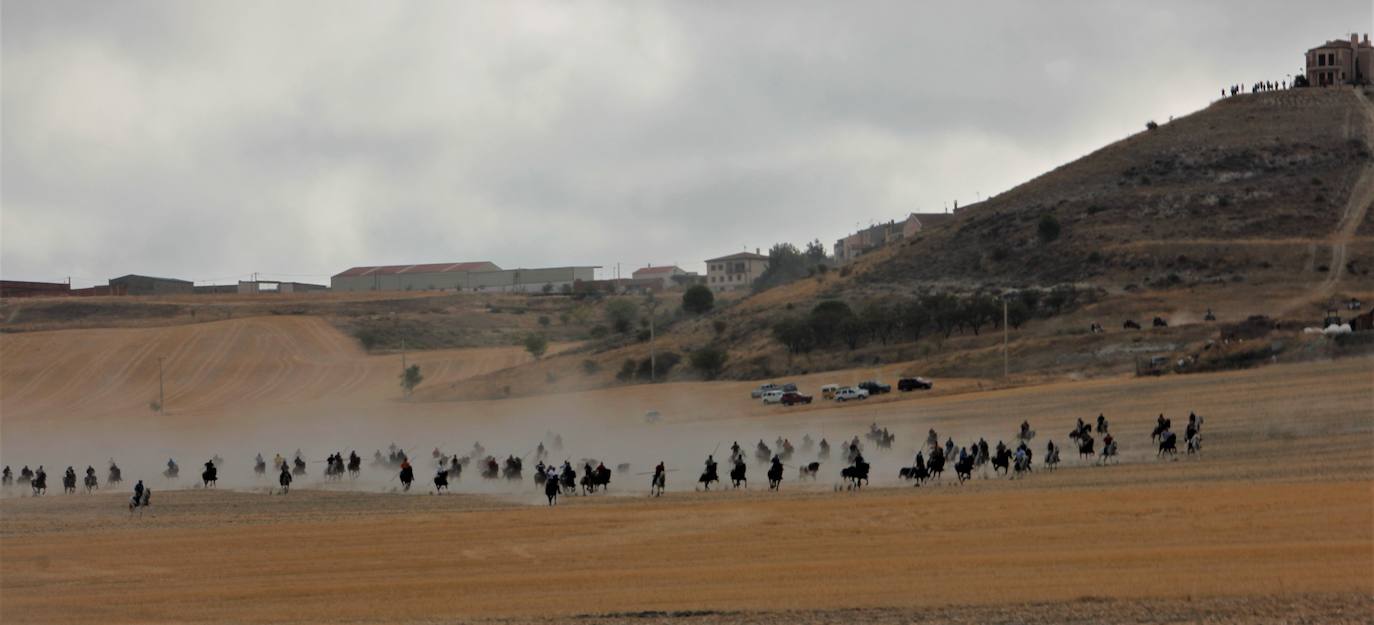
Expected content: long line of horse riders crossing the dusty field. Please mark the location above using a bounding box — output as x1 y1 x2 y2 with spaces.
0 413 1202 511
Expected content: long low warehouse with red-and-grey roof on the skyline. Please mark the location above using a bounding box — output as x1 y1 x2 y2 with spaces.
330 261 596 293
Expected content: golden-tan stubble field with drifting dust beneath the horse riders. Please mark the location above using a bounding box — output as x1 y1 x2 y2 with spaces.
0 342 1374 622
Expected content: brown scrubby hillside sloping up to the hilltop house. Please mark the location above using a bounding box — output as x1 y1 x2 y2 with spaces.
431 89 1374 397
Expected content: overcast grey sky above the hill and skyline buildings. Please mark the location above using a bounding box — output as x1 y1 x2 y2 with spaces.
0 0 1374 286
